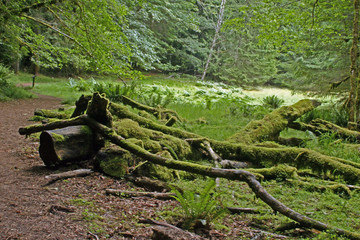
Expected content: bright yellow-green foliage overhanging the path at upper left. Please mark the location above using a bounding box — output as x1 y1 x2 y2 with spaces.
0 0 136 76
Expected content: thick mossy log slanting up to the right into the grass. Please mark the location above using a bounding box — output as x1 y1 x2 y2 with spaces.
228 99 319 144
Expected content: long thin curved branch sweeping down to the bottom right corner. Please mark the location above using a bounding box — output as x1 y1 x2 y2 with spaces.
79 116 360 239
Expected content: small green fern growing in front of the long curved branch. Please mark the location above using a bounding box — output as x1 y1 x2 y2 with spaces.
172 180 227 229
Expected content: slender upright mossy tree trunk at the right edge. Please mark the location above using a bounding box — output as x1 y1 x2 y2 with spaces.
348 0 359 126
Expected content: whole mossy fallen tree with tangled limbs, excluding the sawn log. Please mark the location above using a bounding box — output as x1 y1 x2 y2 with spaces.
19 94 360 239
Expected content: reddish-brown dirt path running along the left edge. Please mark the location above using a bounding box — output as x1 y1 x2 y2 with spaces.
0 96 87 240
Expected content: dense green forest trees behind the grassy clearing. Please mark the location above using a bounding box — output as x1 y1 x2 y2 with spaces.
0 0 353 90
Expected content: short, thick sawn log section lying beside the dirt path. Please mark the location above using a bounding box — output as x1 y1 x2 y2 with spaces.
39 125 96 167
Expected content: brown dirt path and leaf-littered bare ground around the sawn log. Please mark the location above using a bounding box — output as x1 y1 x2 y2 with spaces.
0 95 270 240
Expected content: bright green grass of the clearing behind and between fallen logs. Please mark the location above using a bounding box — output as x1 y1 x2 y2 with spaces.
12 74 360 240
